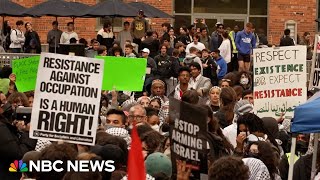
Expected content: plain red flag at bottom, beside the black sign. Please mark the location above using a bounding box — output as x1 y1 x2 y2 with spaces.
128 125 146 180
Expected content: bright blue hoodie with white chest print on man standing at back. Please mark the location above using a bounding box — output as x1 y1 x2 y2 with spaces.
235 30 256 54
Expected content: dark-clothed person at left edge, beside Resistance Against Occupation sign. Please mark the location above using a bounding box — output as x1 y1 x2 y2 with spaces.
0 93 37 180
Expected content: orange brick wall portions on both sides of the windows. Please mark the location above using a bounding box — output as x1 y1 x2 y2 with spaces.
5 0 317 44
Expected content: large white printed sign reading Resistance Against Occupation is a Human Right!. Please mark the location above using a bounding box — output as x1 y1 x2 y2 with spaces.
30 53 104 145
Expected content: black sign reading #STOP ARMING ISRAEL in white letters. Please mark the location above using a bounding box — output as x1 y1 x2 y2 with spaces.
169 98 208 179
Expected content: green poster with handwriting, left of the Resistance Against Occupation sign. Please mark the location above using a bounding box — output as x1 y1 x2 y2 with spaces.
12 56 40 92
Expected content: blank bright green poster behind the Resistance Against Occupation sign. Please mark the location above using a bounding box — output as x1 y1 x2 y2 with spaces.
96 56 147 91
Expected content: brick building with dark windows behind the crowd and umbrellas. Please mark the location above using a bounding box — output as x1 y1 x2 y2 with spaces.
6 0 319 44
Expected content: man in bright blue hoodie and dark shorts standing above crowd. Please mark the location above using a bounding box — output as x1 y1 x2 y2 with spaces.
236 22 256 71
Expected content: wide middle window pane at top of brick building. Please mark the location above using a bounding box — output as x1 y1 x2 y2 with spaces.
193 0 248 14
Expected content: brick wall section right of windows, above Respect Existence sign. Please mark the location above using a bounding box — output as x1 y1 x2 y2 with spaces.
268 0 317 44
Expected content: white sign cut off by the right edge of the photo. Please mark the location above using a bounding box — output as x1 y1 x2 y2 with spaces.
309 35 320 90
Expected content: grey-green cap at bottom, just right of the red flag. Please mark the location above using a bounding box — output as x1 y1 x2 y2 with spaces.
145 152 172 177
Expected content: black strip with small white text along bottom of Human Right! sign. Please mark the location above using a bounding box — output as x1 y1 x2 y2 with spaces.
33 131 93 143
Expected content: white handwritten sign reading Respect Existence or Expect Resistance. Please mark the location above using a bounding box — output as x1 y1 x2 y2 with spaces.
253 46 307 118
